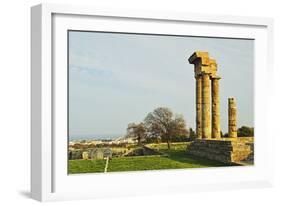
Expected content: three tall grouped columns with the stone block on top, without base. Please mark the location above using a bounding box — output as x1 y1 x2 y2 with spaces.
188 51 220 139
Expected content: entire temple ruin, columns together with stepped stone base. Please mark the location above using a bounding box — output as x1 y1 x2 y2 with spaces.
187 51 253 163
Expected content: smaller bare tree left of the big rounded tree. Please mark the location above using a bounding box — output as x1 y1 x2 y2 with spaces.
127 122 146 145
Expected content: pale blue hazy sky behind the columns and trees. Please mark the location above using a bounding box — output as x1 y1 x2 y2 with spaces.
69 31 254 137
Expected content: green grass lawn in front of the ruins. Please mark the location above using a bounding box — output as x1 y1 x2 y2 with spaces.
69 143 226 174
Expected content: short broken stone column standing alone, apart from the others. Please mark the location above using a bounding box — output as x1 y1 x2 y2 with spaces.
228 98 237 137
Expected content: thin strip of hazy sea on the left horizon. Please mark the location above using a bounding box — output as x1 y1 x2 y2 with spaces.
69 134 125 141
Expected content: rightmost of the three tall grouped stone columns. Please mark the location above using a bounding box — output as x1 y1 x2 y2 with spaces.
211 76 221 138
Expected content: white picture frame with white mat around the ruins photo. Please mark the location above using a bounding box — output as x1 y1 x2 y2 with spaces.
31 4 273 201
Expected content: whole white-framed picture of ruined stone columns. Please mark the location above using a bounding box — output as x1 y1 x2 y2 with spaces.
31 4 273 201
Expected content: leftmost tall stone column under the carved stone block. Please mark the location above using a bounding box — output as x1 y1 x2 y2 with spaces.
195 75 202 139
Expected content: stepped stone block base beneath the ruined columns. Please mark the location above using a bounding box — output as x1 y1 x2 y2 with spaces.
187 138 254 163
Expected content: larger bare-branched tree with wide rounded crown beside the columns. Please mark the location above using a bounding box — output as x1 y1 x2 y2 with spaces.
144 107 188 149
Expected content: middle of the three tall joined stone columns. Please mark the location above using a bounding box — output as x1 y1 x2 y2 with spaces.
202 73 211 139
